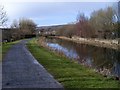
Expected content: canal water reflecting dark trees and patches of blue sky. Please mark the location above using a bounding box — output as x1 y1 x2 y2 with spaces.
45 38 120 77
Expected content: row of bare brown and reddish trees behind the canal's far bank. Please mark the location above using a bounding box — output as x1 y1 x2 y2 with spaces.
56 7 120 39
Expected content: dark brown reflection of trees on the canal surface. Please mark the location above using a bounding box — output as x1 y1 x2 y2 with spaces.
45 39 120 75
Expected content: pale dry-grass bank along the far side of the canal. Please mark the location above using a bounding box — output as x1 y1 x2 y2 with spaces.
55 36 120 49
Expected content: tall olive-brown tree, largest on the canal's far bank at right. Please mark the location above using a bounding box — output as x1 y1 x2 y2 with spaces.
90 7 115 39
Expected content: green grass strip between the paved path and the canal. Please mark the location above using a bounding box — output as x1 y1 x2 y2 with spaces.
27 39 120 88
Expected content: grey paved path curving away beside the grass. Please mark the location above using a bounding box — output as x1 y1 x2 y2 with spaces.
2 40 62 88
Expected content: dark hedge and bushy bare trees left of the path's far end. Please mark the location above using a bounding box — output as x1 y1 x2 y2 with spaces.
2 18 36 41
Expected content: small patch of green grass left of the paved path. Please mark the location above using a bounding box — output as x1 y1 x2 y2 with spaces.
0 40 20 62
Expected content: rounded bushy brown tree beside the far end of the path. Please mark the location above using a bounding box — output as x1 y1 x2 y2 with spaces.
11 18 36 40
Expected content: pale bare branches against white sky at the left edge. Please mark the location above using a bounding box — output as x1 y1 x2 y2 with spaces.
0 6 8 27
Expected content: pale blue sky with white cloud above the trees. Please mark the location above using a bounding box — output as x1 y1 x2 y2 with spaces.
0 0 117 26
